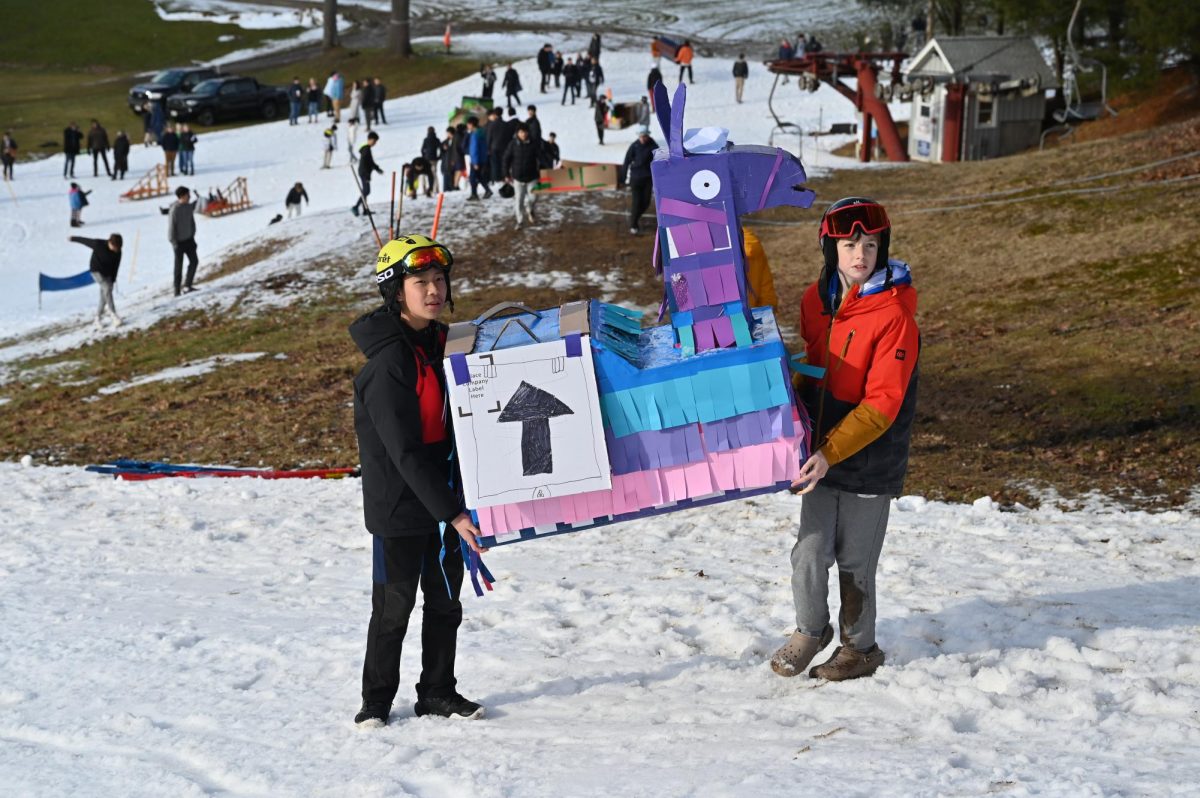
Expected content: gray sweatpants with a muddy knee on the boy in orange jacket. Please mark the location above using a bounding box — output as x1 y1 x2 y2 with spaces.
792 482 892 652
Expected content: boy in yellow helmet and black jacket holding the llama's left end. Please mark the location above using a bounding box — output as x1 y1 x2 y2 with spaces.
350 234 484 726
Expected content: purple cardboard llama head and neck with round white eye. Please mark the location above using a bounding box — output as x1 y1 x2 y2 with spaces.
650 83 815 354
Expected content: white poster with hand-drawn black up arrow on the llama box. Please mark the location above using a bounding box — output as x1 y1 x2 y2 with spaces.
446 336 612 508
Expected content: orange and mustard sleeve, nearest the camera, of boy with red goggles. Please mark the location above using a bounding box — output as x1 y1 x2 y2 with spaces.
821 311 920 466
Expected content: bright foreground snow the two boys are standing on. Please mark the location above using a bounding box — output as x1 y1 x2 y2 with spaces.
0 464 1200 798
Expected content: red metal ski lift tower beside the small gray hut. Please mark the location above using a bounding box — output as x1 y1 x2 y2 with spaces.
767 52 908 162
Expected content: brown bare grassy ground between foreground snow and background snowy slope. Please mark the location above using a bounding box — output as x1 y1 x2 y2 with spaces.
0 94 1200 506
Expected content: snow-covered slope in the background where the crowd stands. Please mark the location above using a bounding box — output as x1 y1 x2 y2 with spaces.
0 36 899 364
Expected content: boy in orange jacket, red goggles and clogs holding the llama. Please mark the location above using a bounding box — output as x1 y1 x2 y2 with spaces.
770 197 920 680
